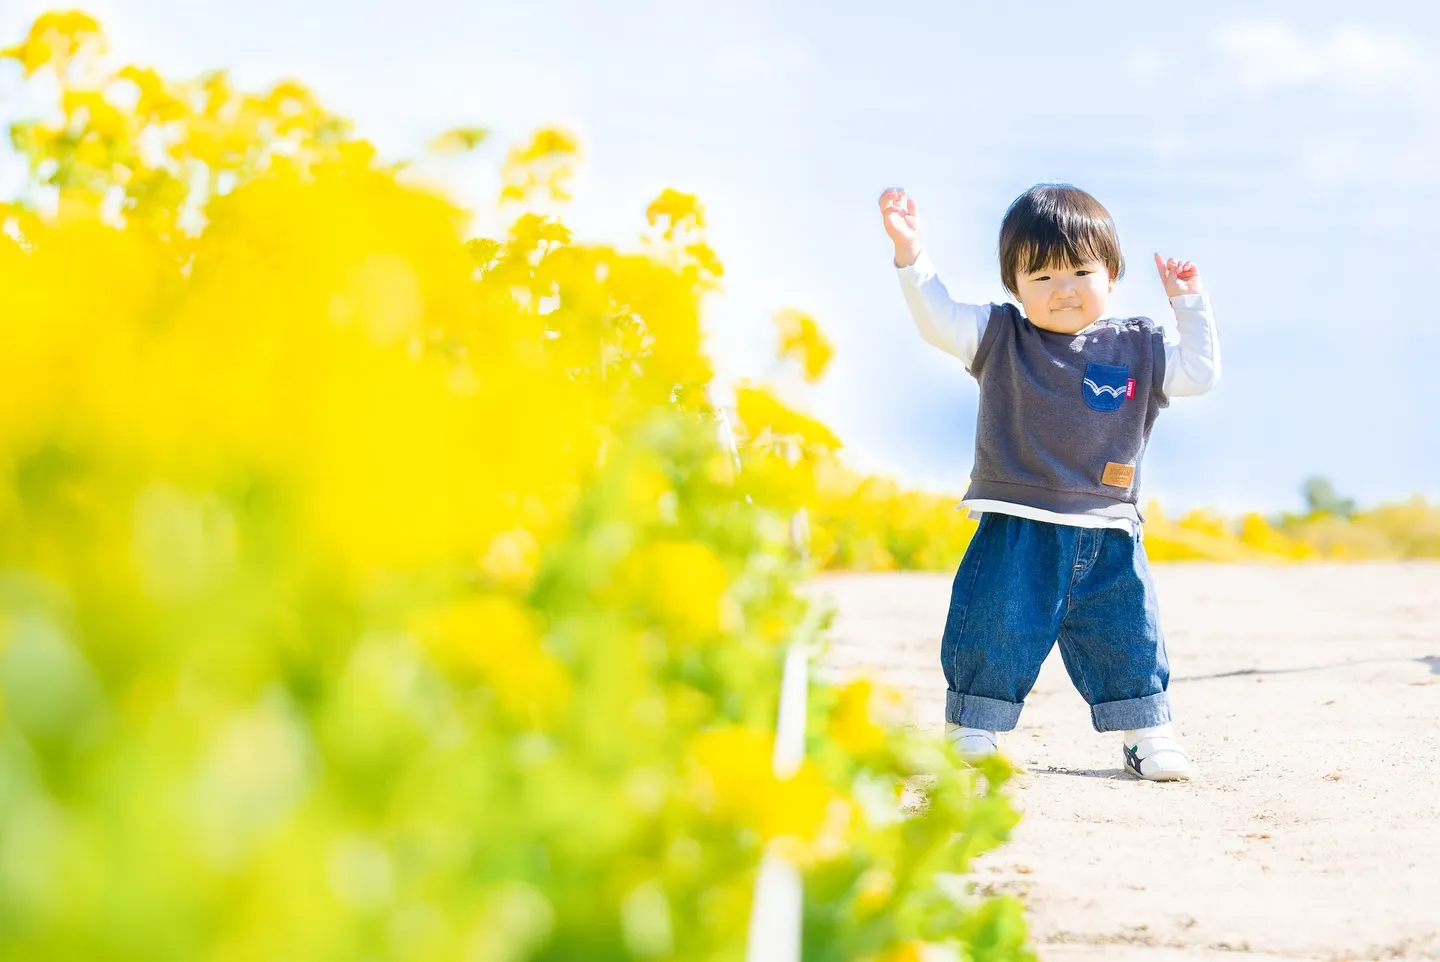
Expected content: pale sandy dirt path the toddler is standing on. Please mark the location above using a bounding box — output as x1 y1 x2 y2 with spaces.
811 563 1440 962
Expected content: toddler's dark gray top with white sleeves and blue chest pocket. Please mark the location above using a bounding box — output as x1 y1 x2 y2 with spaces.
899 251 1220 530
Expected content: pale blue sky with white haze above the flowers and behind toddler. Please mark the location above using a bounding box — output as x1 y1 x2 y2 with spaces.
0 0 1440 510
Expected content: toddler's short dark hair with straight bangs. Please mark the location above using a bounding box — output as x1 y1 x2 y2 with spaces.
999 184 1125 297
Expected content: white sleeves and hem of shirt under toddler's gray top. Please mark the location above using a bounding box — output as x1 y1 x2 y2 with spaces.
899 251 1220 534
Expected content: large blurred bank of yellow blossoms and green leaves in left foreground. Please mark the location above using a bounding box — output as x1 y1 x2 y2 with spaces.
0 14 1036 962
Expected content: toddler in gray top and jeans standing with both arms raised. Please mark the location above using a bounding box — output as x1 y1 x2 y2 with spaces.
880 184 1220 781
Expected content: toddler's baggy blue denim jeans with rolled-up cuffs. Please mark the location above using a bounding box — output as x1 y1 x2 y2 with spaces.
940 513 1171 732
